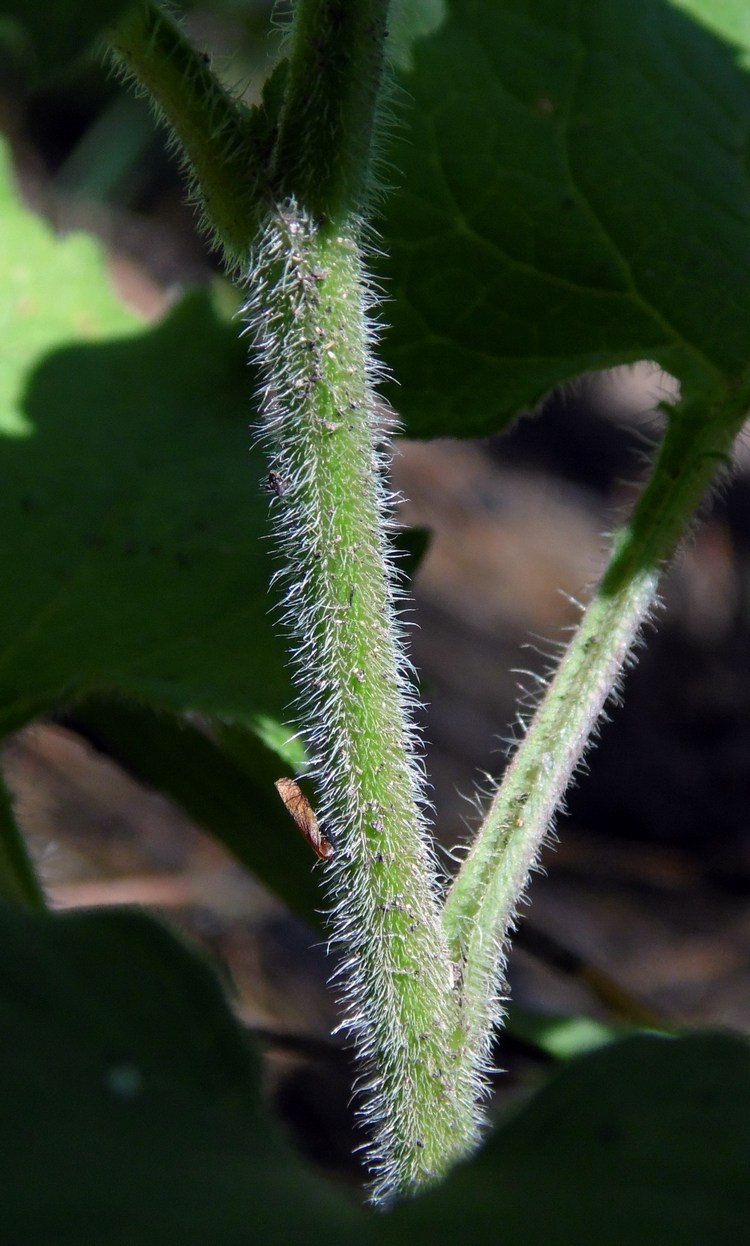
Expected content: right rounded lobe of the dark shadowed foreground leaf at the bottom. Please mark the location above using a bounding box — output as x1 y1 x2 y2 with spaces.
377 1034 750 1246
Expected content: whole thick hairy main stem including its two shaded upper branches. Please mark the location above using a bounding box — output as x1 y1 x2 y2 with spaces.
102 0 476 1199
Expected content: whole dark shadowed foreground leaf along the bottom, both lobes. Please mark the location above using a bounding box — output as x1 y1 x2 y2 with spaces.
7 908 750 1246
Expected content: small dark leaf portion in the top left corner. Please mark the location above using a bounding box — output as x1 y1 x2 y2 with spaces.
0 0 127 77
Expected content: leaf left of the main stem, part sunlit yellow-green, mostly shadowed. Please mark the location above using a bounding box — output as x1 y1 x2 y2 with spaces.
0 143 290 730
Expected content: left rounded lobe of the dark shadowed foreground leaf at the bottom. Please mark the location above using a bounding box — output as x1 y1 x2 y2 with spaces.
0 908 368 1246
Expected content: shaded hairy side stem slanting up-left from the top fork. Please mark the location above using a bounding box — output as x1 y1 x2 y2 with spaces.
107 0 274 268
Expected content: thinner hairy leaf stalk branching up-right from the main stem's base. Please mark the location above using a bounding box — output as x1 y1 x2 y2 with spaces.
444 383 750 1067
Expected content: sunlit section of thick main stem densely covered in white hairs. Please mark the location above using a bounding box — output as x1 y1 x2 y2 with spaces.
248 206 476 1200
